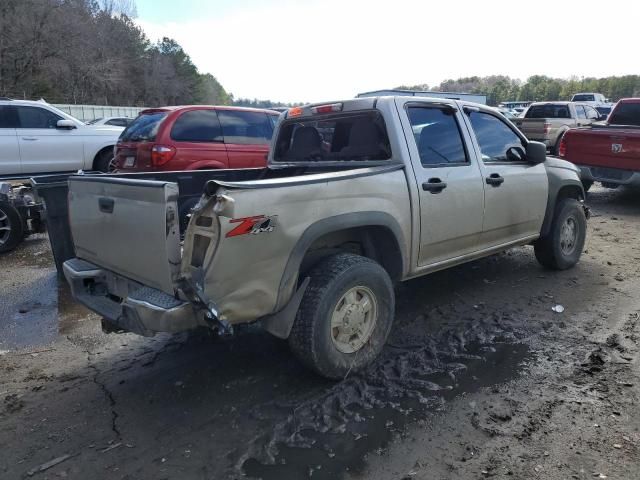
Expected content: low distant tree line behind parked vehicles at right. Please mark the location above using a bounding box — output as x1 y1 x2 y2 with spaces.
398 75 640 105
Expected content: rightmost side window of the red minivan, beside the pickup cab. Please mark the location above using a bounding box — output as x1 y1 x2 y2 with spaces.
218 110 273 145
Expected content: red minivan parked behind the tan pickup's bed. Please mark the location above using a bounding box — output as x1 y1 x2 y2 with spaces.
113 105 279 172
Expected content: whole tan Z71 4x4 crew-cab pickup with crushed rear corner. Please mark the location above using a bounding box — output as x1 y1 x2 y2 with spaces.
57 97 588 378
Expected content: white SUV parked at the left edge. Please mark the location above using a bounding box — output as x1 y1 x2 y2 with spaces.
0 98 124 176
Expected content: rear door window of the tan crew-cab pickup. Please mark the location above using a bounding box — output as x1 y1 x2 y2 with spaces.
408 107 469 167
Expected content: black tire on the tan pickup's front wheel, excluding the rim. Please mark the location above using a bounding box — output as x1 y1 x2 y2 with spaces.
534 198 587 270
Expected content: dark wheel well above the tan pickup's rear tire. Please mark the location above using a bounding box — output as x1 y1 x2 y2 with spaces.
298 225 403 281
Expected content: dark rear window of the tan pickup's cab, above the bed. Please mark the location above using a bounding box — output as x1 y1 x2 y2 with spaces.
274 111 391 162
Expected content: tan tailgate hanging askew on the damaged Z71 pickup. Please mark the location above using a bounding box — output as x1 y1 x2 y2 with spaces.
69 176 181 295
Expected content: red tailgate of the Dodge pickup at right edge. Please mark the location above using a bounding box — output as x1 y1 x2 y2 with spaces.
565 127 640 170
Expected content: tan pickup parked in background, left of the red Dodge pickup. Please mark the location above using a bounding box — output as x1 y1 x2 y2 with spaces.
514 102 604 155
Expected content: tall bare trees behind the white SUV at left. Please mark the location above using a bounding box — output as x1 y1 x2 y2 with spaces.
0 0 233 106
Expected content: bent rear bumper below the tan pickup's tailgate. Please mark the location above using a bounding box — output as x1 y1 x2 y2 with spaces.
63 258 206 336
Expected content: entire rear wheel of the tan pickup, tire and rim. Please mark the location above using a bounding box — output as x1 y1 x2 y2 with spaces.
289 253 395 379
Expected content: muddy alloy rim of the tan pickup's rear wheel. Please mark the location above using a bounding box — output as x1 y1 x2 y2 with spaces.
331 286 378 353
